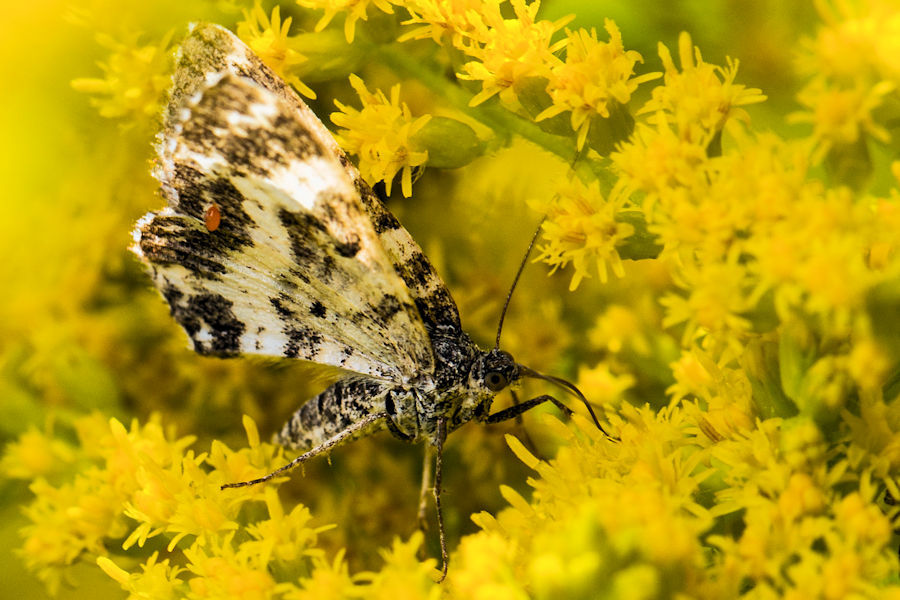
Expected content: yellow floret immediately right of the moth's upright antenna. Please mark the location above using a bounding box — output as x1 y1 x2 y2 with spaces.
535 182 634 290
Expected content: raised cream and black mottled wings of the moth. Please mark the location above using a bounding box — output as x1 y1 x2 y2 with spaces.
133 25 442 382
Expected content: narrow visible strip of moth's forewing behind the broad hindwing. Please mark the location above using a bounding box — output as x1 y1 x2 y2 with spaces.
165 24 461 331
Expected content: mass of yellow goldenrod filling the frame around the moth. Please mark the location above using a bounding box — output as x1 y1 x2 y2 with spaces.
0 0 900 600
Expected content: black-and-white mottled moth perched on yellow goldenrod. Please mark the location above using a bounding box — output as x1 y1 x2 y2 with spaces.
132 24 602 575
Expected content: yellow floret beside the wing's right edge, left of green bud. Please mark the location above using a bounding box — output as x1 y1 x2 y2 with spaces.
331 75 430 197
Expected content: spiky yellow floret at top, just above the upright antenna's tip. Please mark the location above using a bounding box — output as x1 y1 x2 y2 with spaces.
535 19 660 150
